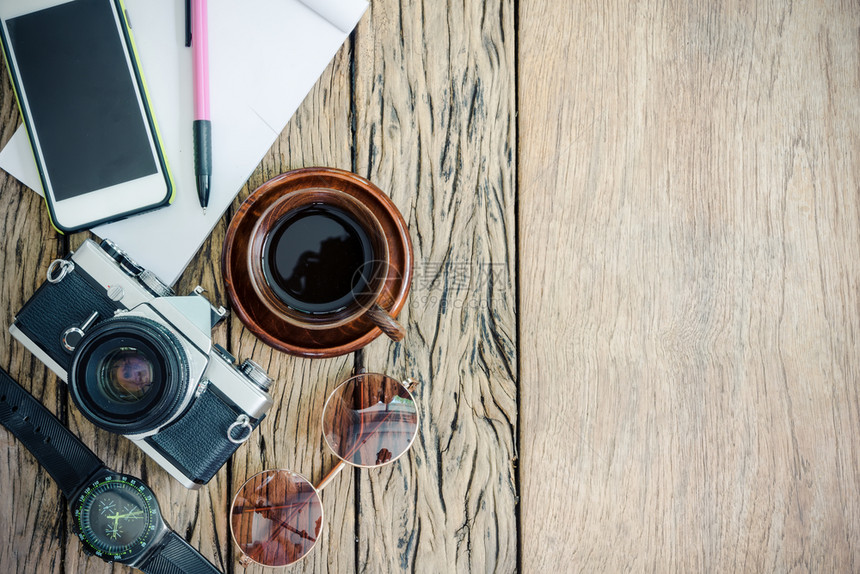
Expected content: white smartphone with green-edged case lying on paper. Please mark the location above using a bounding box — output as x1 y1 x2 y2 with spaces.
0 0 174 233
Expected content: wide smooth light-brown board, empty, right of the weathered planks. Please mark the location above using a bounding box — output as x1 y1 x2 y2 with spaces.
518 0 860 572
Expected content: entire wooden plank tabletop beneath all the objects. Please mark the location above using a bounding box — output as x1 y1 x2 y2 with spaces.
0 0 860 573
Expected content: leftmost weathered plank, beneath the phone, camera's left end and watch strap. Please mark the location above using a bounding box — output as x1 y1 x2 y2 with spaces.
0 64 67 573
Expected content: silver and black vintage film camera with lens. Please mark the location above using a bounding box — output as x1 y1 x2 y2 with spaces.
9 239 272 489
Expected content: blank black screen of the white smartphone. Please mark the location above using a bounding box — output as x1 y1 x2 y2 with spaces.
6 0 157 201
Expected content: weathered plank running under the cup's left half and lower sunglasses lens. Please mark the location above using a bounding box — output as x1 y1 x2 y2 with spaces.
227 41 355 574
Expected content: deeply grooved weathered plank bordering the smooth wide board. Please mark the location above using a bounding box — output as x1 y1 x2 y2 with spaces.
355 0 518 572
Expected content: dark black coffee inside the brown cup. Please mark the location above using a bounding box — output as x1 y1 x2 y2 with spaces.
263 203 373 314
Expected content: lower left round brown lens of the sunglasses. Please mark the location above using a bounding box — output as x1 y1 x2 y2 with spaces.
230 470 323 566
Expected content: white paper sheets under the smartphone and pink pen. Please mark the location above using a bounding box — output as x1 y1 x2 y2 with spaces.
0 0 367 284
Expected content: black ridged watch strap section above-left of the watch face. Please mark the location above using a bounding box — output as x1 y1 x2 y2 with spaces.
0 369 104 500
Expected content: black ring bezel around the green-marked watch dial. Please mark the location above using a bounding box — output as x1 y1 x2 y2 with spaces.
71 469 168 565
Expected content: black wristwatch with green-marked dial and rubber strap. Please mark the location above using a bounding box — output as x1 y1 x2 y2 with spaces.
0 369 220 574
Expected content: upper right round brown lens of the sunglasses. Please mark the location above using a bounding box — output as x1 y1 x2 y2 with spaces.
323 373 418 466
